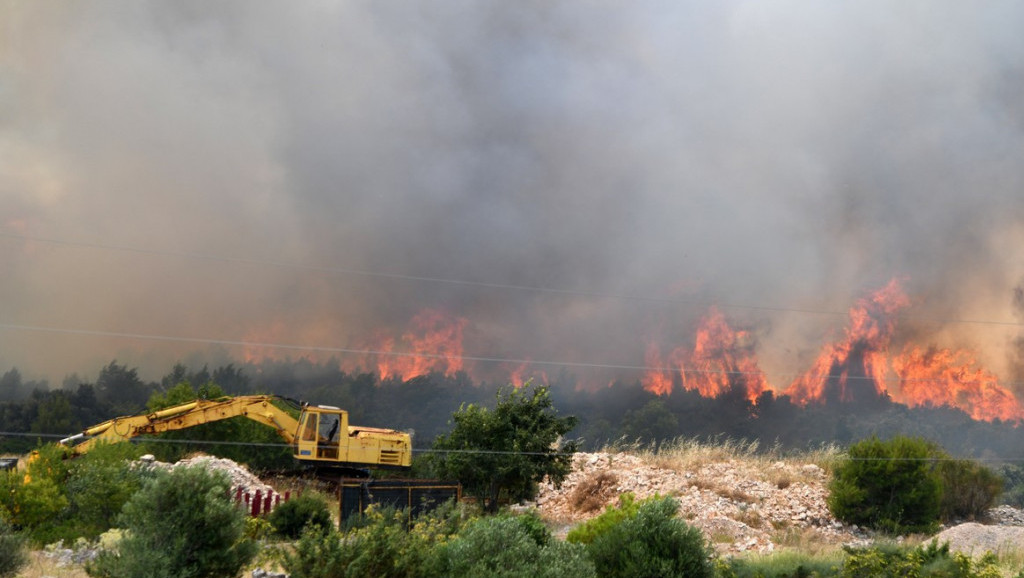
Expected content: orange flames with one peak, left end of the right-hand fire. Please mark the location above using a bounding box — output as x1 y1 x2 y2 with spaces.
641 307 769 402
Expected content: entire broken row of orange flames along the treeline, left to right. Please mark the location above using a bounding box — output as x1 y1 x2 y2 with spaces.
246 280 1024 422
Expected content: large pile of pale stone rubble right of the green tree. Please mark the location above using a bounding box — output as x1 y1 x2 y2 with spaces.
537 453 867 552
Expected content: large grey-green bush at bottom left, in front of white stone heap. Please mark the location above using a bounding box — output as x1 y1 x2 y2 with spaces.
86 467 257 578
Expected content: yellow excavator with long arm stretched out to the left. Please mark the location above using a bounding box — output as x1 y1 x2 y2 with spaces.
60 396 413 471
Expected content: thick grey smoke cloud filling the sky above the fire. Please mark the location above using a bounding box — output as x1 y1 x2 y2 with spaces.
0 0 1024 391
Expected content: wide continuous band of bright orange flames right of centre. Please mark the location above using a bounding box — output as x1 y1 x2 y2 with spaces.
643 280 1024 421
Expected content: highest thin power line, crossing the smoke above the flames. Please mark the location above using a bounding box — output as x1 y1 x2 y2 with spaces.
0 231 1024 327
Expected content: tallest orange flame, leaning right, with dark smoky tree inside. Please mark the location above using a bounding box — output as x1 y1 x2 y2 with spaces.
786 279 910 405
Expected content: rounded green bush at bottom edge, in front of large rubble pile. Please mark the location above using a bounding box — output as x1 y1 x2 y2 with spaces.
587 497 714 578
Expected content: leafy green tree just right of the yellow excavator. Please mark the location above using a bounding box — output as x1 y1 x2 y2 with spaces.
430 383 577 512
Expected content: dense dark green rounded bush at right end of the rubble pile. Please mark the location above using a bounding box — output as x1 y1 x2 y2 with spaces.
827 437 943 534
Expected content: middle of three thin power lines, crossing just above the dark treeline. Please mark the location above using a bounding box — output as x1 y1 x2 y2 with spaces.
0 323 1024 386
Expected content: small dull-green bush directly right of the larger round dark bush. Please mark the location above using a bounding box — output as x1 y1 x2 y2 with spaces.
935 459 1002 522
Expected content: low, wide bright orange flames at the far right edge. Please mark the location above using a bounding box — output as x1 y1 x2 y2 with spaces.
893 346 1024 421
